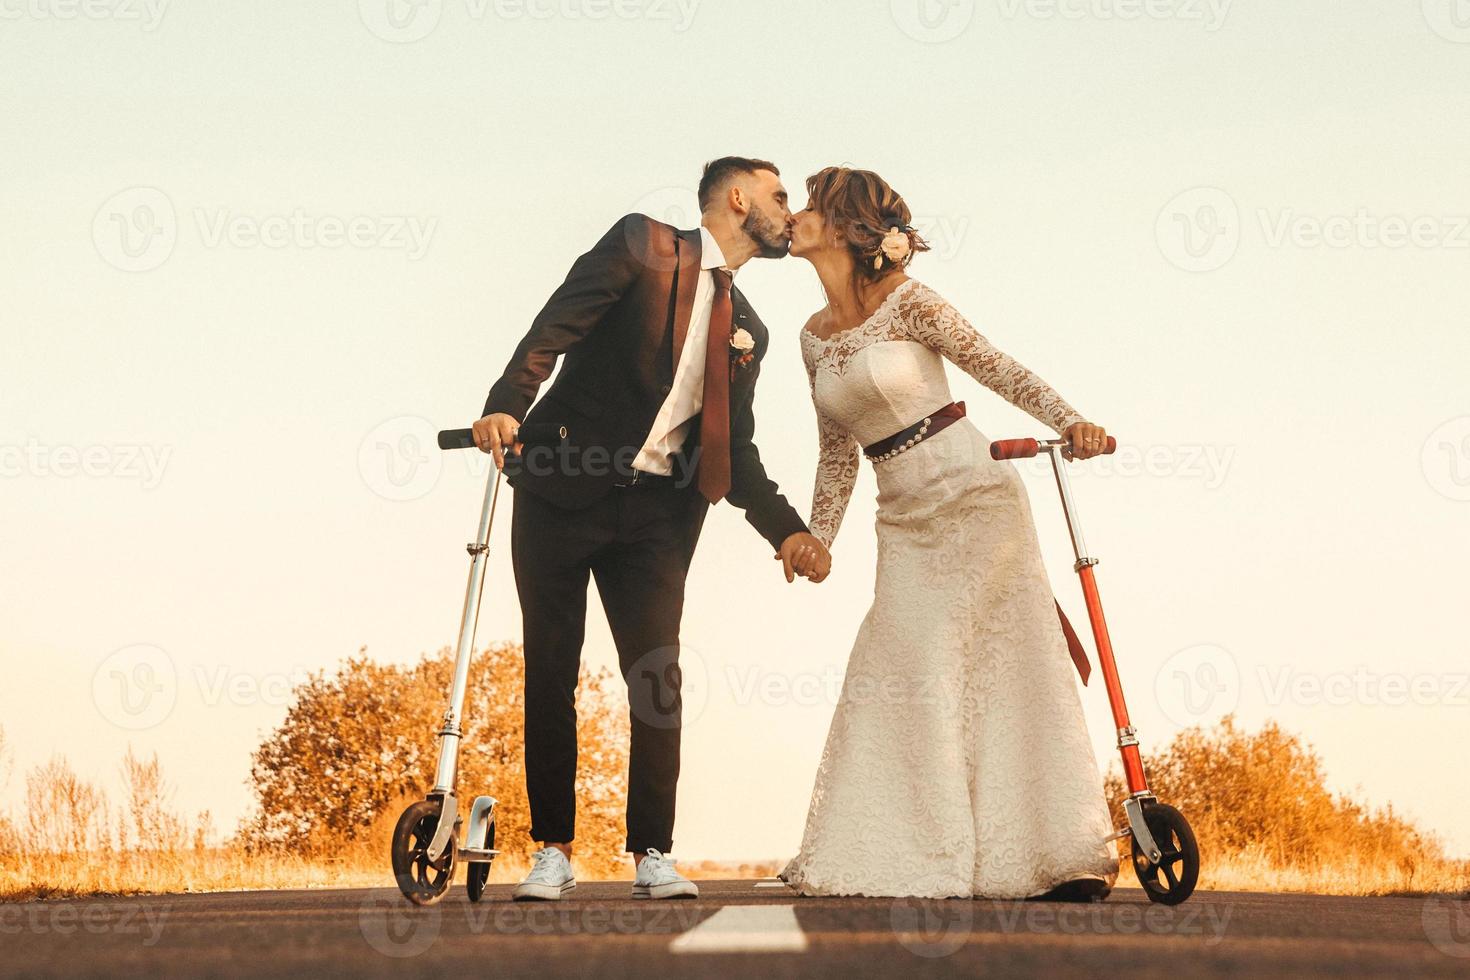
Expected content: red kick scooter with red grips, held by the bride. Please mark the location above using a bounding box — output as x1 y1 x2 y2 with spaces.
991 436 1200 905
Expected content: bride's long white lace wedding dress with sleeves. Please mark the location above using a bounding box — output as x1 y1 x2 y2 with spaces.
781 279 1117 898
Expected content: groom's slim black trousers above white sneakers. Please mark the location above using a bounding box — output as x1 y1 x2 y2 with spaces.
510 482 709 854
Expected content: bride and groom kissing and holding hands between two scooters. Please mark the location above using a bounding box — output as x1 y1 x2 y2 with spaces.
473 157 1117 901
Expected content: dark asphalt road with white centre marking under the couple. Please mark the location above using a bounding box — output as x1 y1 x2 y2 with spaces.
0 880 1470 980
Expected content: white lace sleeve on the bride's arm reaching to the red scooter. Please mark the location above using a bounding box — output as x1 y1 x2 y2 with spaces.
898 284 1086 435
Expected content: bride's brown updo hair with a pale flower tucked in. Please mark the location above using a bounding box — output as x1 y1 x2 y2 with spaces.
807 166 929 285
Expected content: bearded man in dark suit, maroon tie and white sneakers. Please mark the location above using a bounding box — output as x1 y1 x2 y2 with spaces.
473 157 831 899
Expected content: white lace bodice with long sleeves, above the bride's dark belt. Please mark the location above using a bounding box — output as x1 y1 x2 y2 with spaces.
801 279 1085 545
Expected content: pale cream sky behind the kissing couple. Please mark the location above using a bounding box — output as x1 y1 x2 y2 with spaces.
0 0 1470 858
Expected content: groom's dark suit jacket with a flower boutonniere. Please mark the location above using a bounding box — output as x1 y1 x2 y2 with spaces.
484 215 807 550
